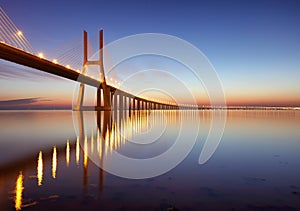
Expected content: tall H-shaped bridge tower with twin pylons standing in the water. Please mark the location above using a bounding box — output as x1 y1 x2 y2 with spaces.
74 29 111 111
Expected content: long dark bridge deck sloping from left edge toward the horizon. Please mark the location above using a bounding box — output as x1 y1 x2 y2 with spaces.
0 42 197 109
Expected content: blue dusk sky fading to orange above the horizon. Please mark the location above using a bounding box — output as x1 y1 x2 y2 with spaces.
0 0 300 108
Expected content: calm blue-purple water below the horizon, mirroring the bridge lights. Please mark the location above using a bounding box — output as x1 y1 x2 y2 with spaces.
0 110 300 210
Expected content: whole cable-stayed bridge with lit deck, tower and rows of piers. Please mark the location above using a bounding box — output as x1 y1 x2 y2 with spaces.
0 8 198 111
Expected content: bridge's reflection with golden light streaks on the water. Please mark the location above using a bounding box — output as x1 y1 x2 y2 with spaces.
14 110 199 210
